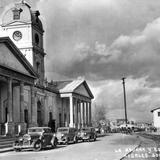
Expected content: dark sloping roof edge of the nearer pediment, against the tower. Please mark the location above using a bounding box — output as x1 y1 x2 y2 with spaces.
0 37 39 79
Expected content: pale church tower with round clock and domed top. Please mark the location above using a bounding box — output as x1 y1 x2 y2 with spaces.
1 0 45 84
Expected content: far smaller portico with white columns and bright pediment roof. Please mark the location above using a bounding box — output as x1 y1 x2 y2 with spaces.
60 79 94 129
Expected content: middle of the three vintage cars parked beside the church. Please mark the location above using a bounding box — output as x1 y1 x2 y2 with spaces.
56 127 78 144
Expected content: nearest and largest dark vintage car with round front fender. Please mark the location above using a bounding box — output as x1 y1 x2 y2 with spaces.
13 127 57 151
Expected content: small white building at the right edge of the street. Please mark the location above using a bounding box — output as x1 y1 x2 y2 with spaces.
151 107 160 128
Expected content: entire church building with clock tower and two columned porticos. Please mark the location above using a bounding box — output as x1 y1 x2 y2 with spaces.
0 1 94 135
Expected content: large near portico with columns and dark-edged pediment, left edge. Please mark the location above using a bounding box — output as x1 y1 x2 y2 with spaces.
0 38 36 135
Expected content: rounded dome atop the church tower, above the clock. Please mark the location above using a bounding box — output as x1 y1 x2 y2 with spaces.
2 0 43 32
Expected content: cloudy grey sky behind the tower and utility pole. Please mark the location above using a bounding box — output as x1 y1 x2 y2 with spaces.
1 0 160 122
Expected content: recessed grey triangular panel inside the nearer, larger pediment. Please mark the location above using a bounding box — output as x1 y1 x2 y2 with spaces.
0 43 31 75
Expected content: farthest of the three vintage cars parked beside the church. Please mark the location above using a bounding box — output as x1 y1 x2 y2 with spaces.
78 127 97 141
